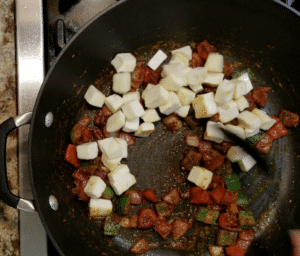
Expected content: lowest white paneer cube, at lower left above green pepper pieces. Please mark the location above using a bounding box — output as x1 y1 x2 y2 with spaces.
89 198 113 217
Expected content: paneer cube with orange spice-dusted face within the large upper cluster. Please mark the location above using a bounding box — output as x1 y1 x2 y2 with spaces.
192 92 217 118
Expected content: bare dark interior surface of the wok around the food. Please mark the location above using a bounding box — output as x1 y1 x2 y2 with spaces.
30 0 300 255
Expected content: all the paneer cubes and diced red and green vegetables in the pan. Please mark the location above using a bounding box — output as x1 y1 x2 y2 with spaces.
64 41 299 256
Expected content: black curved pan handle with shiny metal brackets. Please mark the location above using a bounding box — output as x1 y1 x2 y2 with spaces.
0 112 35 212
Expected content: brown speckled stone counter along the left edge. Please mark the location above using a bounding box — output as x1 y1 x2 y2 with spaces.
0 0 19 255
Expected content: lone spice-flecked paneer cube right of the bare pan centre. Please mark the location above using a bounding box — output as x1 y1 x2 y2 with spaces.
188 166 213 190
